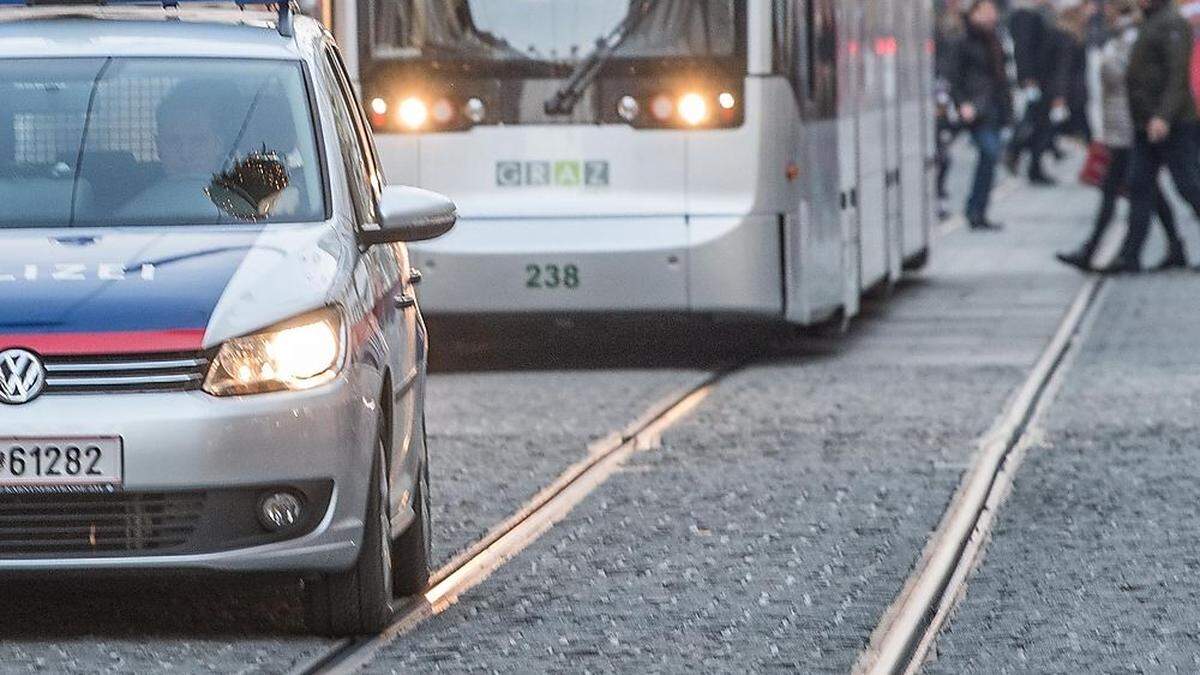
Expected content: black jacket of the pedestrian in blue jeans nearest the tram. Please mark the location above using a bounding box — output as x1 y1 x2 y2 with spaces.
946 26 1013 126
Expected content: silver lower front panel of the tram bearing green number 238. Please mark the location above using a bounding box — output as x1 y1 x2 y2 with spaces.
412 215 782 316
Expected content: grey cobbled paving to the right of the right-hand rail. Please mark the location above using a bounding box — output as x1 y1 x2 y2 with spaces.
926 273 1200 673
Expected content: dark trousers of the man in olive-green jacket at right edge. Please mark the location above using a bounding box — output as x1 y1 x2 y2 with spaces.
1121 125 1200 265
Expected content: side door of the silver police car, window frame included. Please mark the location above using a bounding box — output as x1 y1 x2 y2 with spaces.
324 44 424 514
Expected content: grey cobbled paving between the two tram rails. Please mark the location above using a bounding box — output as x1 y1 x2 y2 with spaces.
360 153 1090 673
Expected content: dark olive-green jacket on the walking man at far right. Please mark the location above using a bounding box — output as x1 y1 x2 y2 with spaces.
1126 2 1198 130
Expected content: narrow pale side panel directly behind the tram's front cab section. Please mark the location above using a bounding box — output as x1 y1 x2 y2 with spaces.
836 2 863 317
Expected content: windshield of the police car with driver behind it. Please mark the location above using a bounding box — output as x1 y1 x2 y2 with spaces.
0 59 325 228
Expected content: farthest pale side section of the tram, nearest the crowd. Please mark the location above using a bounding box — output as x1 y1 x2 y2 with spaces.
896 0 929 262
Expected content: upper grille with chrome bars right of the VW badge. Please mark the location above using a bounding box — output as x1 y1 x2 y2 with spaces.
44 353 210 394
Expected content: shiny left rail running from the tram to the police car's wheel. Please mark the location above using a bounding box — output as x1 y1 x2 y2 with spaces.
289 364 744 675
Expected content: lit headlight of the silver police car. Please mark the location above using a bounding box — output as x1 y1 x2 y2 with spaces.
204 307 346 396
